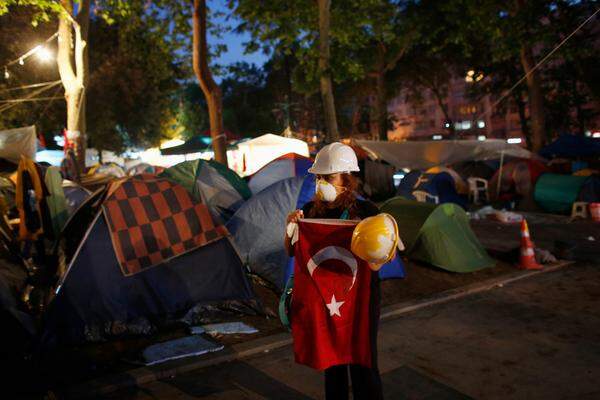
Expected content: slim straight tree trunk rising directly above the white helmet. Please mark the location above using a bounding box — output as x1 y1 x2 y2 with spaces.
318 0 340 143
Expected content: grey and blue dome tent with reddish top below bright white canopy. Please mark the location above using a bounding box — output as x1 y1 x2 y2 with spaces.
248 153 313 193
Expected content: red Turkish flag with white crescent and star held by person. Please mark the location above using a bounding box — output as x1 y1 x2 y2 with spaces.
291 219 371 370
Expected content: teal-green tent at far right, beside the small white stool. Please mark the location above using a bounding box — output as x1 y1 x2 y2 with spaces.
533 173 588 213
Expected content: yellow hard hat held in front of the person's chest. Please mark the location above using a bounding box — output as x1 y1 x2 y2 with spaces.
350 213 401 269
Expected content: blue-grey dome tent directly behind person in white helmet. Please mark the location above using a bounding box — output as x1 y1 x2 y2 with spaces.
227 175 404 289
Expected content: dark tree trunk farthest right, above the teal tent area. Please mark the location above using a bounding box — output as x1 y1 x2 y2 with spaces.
520 45 546 152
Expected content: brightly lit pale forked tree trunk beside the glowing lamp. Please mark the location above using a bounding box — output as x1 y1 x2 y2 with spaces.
56 0 90 171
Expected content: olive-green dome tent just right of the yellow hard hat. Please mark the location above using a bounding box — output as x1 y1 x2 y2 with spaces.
381 197 495 272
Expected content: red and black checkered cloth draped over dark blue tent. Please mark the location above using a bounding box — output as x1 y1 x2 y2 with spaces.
102 175 228 276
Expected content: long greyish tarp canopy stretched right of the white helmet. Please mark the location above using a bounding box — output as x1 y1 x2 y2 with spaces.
357 139 539 169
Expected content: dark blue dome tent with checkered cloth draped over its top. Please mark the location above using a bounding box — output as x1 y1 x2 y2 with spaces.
45 175 254 342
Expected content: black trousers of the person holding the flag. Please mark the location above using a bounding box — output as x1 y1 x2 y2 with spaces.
325 272 383 400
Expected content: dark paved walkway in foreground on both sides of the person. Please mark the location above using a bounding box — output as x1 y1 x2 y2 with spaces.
102 266 600 400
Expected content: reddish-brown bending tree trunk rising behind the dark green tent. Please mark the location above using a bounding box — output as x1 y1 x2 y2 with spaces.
192 0 227 165
